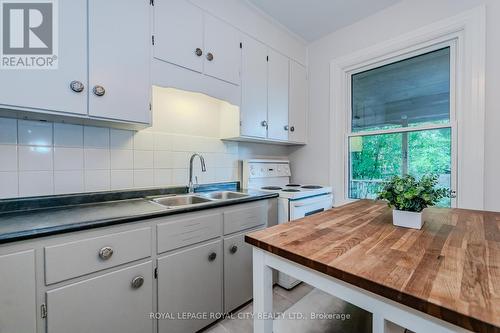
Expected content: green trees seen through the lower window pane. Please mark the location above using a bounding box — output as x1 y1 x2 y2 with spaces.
349 128 451 207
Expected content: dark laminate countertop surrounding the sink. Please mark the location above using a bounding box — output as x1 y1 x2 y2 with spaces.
0 183 277 244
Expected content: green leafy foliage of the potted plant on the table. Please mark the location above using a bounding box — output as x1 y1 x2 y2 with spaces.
377 175 451 212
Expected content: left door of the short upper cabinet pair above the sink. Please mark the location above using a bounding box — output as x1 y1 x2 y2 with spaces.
154 0 204 72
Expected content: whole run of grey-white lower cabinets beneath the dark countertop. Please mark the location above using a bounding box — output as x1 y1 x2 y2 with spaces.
0 199 277 333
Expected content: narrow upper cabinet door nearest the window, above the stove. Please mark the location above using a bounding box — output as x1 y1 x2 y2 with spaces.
288 60 307 143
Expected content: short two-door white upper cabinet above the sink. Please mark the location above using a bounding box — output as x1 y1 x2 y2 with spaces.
154 0 241 86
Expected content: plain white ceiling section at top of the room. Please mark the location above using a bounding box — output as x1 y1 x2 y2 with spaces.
248 0 401 42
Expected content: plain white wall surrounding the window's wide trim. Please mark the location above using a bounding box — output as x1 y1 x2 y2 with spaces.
290 0 500 211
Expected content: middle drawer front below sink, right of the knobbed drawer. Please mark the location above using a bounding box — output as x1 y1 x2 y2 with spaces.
157 213 222 253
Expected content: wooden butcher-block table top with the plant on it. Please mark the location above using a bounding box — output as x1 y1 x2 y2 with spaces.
245 200 500 332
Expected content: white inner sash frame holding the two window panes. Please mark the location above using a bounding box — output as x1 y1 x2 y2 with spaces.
343 38 458 207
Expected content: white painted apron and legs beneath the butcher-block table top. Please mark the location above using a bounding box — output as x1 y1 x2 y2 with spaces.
253 247 470 333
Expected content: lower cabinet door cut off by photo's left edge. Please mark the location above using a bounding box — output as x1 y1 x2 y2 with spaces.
0 250 37 333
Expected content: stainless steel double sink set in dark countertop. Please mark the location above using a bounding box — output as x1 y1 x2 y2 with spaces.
148 191 250 209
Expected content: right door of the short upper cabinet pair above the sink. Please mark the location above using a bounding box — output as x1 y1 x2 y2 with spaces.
204 14 241 85
